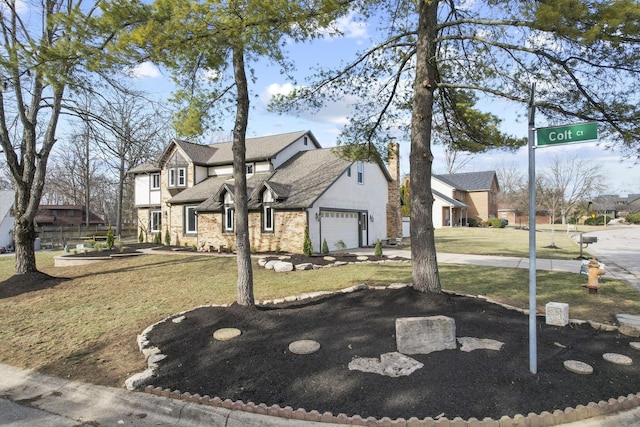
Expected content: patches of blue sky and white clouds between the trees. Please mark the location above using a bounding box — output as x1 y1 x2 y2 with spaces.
126 10 640 195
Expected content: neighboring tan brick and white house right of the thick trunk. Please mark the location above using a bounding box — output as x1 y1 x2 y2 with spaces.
431 171 500 228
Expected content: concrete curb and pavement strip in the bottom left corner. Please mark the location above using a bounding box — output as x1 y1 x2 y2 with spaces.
0 364 335 427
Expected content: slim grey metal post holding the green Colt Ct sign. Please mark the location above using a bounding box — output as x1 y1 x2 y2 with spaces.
528 83 538 374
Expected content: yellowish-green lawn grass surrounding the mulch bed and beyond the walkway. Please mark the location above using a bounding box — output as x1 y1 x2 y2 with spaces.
0 229 640 386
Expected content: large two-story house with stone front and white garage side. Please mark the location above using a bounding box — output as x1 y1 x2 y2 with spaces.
129 131 399 253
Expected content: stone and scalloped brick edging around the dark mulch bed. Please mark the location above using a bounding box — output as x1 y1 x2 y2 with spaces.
130 283 640 427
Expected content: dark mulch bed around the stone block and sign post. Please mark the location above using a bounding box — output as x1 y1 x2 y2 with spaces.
144 288 640 419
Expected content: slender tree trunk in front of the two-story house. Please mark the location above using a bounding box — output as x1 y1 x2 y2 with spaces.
232 46 255 306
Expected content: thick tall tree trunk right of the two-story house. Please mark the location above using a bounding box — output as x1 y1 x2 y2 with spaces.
409 0 441 293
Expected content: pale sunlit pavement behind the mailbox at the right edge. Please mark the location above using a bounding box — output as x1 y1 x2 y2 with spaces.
585 225 640 292
